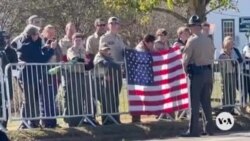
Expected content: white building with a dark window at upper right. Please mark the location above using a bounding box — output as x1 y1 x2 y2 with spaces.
207 0 250 58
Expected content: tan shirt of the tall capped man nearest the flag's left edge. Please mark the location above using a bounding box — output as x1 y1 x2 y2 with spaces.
99 32 126 63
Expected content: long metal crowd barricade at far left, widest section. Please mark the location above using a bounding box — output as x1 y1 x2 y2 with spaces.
5 63 96 128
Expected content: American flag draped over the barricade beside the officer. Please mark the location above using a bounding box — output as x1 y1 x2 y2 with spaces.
125 48 189 115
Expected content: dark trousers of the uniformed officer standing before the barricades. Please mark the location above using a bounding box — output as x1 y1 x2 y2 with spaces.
189 68 213 135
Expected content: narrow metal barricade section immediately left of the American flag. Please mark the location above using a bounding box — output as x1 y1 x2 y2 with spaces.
92 64 129 124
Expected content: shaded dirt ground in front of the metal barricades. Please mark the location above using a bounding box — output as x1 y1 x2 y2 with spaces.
8 114 250 141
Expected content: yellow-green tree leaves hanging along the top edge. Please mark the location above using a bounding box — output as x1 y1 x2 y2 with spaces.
103 0 236 19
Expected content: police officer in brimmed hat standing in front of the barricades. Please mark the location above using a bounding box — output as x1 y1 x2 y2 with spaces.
182 16 214 137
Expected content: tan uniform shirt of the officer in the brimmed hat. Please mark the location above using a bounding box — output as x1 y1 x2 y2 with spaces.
183 33 215 72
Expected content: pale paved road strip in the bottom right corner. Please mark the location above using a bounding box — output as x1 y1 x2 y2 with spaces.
145 131 250 141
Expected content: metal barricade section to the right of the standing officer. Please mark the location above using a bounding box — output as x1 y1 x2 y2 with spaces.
212 59 244 112
